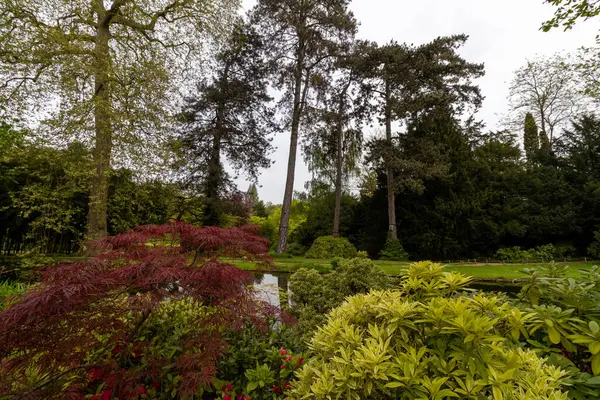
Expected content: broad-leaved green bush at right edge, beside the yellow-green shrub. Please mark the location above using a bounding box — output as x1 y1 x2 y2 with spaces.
517 264 600 400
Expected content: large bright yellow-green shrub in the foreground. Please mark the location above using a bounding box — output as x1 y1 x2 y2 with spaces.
290 263 567 400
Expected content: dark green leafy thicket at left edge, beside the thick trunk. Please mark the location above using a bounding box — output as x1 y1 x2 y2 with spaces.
0 141 91 253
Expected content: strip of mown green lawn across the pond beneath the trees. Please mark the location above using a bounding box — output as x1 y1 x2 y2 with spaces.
235 257 598 279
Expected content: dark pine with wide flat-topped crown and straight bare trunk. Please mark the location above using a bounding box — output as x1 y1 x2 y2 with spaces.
363 35 484 239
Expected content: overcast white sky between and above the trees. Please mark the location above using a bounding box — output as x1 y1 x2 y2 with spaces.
232 0 600 204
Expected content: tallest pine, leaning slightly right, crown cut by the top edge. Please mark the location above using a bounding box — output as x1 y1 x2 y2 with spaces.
251 0 357 253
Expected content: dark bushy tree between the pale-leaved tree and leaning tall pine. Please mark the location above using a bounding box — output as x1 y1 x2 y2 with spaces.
180 25 276 225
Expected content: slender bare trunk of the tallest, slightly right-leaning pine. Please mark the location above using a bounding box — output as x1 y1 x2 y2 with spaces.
277 42 309 254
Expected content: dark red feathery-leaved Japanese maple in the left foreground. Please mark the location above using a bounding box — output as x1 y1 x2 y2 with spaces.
0 222 273 399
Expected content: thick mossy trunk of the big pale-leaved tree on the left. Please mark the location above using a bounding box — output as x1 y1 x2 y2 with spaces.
86 15 113 252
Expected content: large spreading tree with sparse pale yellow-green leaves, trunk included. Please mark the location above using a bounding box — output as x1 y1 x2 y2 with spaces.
0 0 237 245
